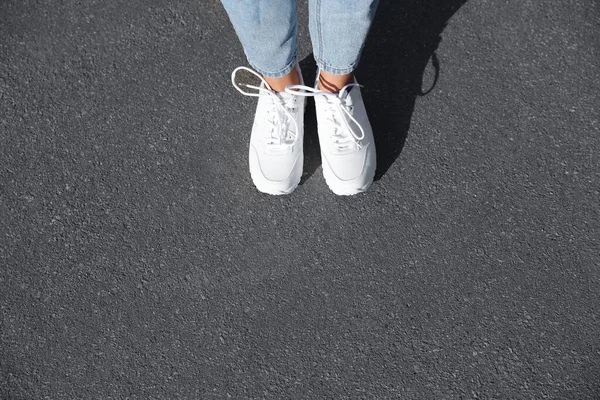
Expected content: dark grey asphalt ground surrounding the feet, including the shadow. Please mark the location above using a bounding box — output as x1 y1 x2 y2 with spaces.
0 0 600 399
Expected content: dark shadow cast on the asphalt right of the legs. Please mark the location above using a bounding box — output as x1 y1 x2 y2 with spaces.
357 0 466 180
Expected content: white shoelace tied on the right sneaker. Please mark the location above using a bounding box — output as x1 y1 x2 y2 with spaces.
285 83 365 148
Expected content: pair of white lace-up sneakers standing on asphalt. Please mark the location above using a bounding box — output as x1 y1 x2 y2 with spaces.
231 66 376 195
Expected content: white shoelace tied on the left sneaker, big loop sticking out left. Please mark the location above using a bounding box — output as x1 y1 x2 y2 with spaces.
231 67 299 146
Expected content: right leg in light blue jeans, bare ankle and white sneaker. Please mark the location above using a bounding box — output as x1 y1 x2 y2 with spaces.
296 0 378 195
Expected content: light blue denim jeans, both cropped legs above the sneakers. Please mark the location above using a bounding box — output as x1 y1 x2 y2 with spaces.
221 0 379 78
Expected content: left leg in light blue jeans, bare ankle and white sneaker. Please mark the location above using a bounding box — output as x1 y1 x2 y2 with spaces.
221 0 305 194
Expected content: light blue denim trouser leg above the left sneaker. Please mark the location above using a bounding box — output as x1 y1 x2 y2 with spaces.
221 0 298 78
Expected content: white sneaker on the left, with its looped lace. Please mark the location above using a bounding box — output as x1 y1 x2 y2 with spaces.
231 66 306 195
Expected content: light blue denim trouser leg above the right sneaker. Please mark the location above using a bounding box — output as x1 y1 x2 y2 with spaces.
309 0 379 75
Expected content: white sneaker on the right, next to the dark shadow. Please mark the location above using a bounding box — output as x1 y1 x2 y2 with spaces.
286 74 376 195
